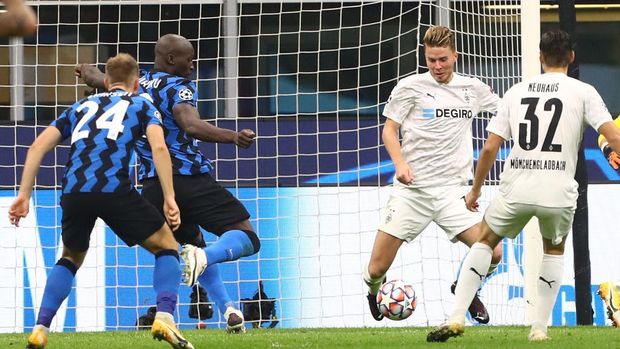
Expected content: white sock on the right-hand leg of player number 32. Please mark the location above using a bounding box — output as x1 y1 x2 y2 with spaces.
532 254 564 333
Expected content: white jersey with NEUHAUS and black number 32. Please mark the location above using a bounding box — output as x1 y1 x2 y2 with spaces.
487 73 612 207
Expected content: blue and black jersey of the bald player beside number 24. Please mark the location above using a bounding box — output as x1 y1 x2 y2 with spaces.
136 70 213 180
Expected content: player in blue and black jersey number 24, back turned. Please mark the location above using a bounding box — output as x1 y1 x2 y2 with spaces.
9 54 193 348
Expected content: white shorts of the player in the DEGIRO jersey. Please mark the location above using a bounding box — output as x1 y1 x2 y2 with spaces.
379 185 482 242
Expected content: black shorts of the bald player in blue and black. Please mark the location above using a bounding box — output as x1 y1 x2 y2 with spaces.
142 173 250 244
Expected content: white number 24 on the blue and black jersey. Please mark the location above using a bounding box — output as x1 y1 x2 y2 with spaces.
71 100 129 144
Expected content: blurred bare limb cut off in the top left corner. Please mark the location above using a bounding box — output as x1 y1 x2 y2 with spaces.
0 0 37 36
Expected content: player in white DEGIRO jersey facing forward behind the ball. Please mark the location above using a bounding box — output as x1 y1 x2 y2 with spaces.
363 26 502 324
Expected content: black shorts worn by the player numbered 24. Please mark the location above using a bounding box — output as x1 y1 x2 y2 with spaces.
60 190 164 252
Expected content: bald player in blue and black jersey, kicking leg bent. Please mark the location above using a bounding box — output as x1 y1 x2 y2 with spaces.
76 34 260 332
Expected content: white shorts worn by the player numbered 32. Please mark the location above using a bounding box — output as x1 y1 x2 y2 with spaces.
484 192 577 245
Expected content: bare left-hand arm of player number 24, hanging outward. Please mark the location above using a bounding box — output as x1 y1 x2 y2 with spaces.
9 126 62 226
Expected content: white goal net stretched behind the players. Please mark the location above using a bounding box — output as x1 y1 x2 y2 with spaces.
0 0 524 332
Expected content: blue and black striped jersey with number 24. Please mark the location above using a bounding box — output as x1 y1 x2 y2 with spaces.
50 90 161 193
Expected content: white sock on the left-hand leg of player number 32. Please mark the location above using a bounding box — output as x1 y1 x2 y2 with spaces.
448 242 493 324
